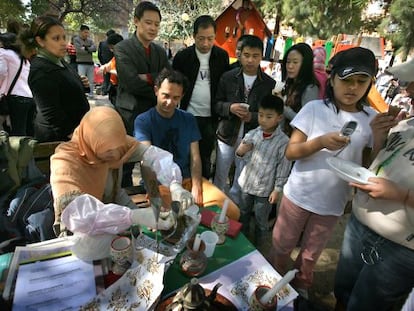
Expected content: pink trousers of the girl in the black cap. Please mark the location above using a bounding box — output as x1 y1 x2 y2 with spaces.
270 196 338 289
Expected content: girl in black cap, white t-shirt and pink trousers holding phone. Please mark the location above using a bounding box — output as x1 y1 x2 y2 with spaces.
271 47 376 297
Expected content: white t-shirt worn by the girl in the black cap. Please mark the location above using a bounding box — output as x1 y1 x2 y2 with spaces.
283 100 376 216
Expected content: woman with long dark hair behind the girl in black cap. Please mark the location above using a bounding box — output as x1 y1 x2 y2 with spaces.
282 43 319 136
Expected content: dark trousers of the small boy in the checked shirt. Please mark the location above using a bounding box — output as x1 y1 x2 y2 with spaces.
240 193 272 235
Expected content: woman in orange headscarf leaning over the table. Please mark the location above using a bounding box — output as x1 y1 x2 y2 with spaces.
50 107 191 235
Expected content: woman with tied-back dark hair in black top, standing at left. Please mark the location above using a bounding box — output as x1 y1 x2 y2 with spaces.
20 16 89 142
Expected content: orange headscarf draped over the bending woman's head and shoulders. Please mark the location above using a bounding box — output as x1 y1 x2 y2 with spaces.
50 107 139 200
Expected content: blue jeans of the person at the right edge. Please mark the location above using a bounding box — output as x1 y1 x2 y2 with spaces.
335 215 414 311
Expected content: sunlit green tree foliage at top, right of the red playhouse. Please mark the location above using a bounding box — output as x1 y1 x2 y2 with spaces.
282 0 369 39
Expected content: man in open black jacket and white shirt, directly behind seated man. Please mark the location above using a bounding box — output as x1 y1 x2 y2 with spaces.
173 15 229 179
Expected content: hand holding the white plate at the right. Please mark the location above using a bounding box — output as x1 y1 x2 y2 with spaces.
350 177 407 202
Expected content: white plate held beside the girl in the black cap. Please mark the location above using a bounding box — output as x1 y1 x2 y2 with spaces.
326 157 376 185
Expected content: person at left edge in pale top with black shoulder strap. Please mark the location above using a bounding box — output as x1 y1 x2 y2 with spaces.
0 32 36 136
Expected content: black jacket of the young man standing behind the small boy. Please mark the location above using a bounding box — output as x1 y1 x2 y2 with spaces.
215 68 275 146
